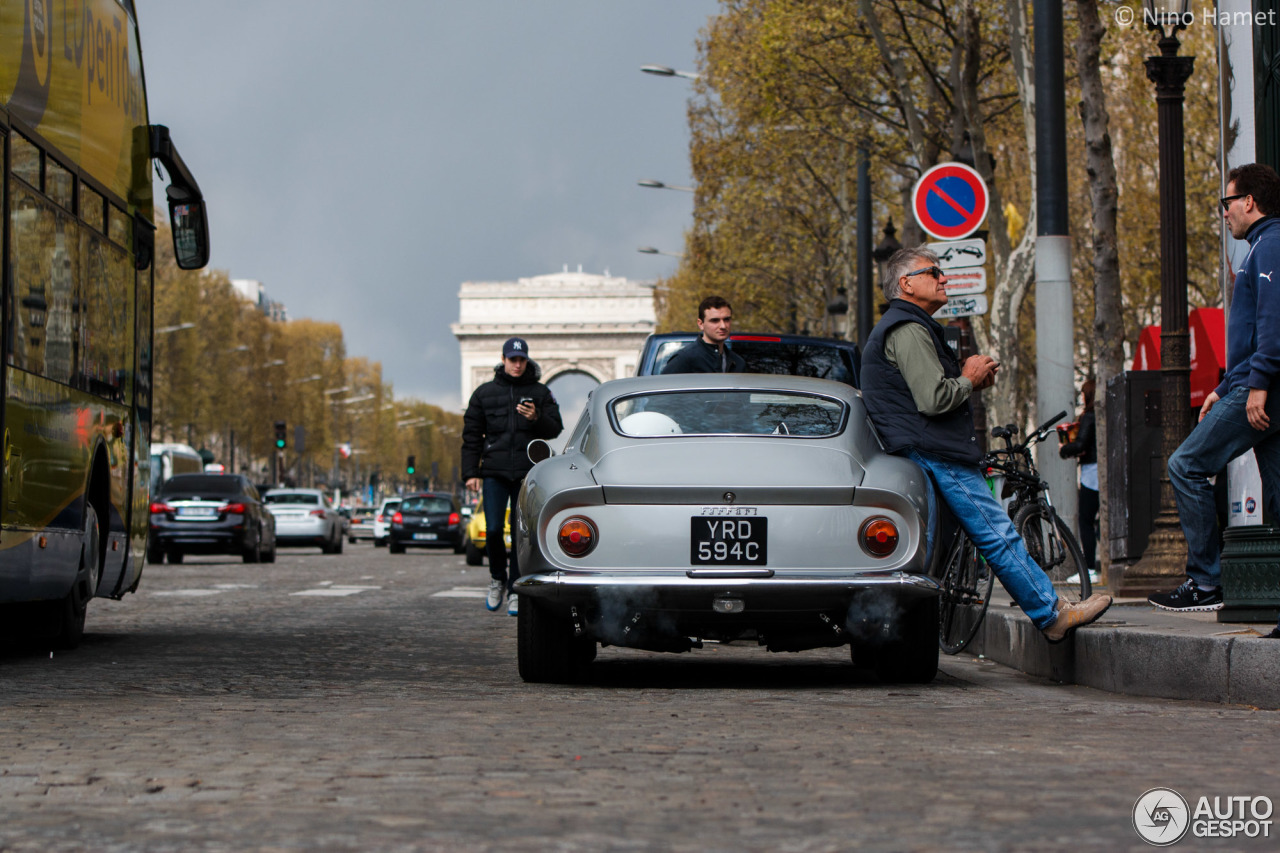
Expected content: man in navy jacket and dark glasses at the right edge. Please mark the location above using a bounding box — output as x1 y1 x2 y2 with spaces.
1147 163 1280 639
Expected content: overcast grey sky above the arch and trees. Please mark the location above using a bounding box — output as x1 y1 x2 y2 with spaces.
137 0 717 410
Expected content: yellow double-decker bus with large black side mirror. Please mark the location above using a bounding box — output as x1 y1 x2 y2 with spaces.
0 0 209 648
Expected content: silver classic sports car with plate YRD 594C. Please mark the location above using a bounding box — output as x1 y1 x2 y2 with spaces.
513 374 938 681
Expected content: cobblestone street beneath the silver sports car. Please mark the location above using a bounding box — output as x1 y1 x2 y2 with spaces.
0 544 1280 852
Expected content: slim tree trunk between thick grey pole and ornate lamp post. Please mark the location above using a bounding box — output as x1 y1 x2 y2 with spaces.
1075 0 1124 578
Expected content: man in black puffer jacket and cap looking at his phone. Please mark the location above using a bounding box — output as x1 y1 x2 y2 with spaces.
462 338 564 616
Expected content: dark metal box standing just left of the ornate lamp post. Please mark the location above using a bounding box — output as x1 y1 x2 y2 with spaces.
1107 370 1164 561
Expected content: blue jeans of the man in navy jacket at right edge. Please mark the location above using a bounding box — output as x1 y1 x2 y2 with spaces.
1169 386 1280 587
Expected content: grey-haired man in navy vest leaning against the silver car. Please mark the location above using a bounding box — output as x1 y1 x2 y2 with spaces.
861 246 1111 643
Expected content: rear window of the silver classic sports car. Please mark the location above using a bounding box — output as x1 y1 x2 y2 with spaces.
611 389 847 438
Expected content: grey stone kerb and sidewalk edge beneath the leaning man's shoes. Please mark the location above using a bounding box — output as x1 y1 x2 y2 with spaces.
966 583 1280 710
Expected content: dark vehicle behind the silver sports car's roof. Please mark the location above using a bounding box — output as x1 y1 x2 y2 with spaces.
636 332 863 388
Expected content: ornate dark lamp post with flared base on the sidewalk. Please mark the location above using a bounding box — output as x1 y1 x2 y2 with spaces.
1120 0 1196 596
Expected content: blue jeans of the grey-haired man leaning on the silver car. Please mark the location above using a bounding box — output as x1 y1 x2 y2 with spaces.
906 448 1057 630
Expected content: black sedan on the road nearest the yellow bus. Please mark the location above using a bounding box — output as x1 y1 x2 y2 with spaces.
147 474 275 562
